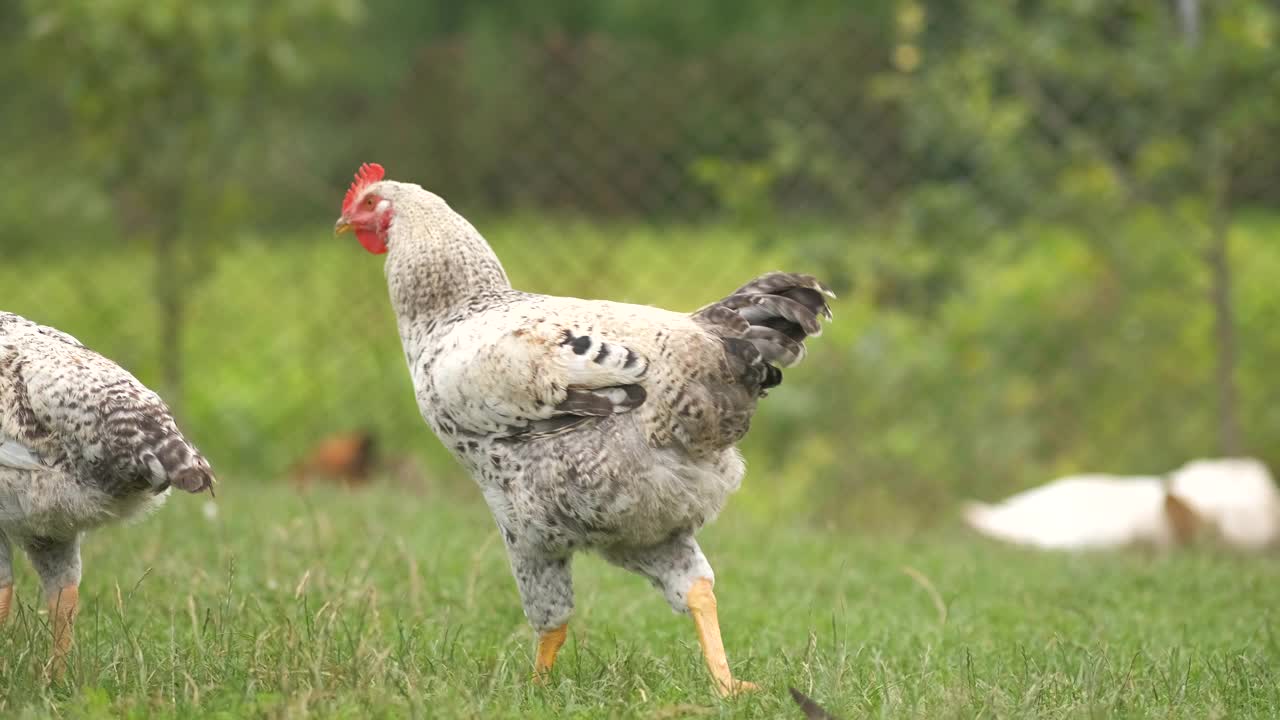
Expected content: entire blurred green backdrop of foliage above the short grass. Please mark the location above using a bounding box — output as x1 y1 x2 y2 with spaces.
0 0 1280 519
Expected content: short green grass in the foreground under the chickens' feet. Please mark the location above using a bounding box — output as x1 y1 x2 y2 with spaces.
0 478 1280 719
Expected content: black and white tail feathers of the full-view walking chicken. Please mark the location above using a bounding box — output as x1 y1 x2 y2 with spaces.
694 273 835 395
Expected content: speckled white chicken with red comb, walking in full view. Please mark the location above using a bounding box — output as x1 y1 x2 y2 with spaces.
337 165 831 694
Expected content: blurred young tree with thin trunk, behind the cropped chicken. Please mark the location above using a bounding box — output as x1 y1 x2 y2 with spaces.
22 0 361 402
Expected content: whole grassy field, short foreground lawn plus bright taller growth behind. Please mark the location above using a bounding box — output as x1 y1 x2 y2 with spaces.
0 212 1280 719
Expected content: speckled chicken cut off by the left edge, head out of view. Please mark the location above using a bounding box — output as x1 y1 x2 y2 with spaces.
0 311 214 673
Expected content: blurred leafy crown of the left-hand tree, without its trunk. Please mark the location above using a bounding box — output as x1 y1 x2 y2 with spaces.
5 0 362 240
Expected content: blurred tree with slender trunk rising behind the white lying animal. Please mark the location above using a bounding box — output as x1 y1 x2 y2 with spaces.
879 0 1280 454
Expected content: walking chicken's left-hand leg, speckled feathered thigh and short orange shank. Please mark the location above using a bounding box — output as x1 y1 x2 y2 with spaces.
511 551 573 682
